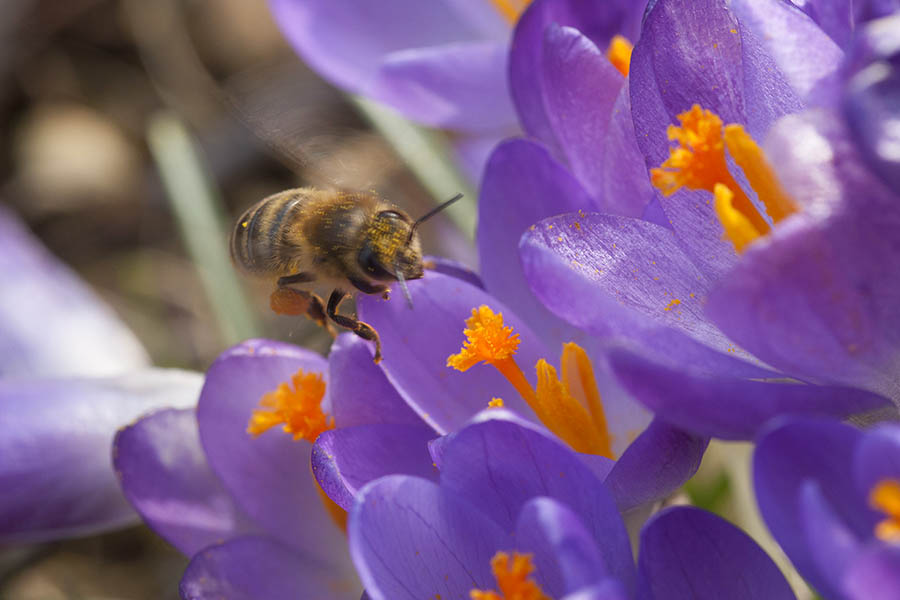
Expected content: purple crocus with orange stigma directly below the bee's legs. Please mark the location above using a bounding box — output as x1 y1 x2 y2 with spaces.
113 334 422 599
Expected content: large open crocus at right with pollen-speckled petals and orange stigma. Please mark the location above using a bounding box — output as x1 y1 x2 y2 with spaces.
492 0 900 439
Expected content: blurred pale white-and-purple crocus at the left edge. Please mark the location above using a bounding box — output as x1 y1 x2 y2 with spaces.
0 207 200 543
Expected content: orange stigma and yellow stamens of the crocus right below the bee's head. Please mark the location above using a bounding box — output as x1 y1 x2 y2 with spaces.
447 305 614 458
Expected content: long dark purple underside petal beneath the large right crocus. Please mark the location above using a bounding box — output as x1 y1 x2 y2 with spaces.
610 348 890 440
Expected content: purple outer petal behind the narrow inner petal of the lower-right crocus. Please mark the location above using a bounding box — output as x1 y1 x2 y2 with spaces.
753 419 877 589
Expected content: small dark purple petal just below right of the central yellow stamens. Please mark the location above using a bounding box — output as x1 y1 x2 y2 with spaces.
604 419 709 512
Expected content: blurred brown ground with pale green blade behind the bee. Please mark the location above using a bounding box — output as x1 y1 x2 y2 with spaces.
0 0 475 600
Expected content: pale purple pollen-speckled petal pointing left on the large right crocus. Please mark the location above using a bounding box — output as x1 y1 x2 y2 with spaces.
519 215 778 378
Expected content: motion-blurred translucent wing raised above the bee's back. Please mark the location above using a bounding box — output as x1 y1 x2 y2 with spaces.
222 61 399 189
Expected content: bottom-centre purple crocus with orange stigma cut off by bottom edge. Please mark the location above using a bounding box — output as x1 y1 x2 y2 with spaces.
348 409 794 600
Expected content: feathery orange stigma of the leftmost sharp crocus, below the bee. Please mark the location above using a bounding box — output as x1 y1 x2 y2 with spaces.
247 369 334 442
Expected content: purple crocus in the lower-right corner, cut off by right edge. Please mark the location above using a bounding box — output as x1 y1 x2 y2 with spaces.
753 419 900 600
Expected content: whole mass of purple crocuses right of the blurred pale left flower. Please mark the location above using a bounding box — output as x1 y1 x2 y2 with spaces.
8 0 900 600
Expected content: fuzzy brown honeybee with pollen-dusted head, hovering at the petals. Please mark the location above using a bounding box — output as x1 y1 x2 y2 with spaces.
230 188 462 363
